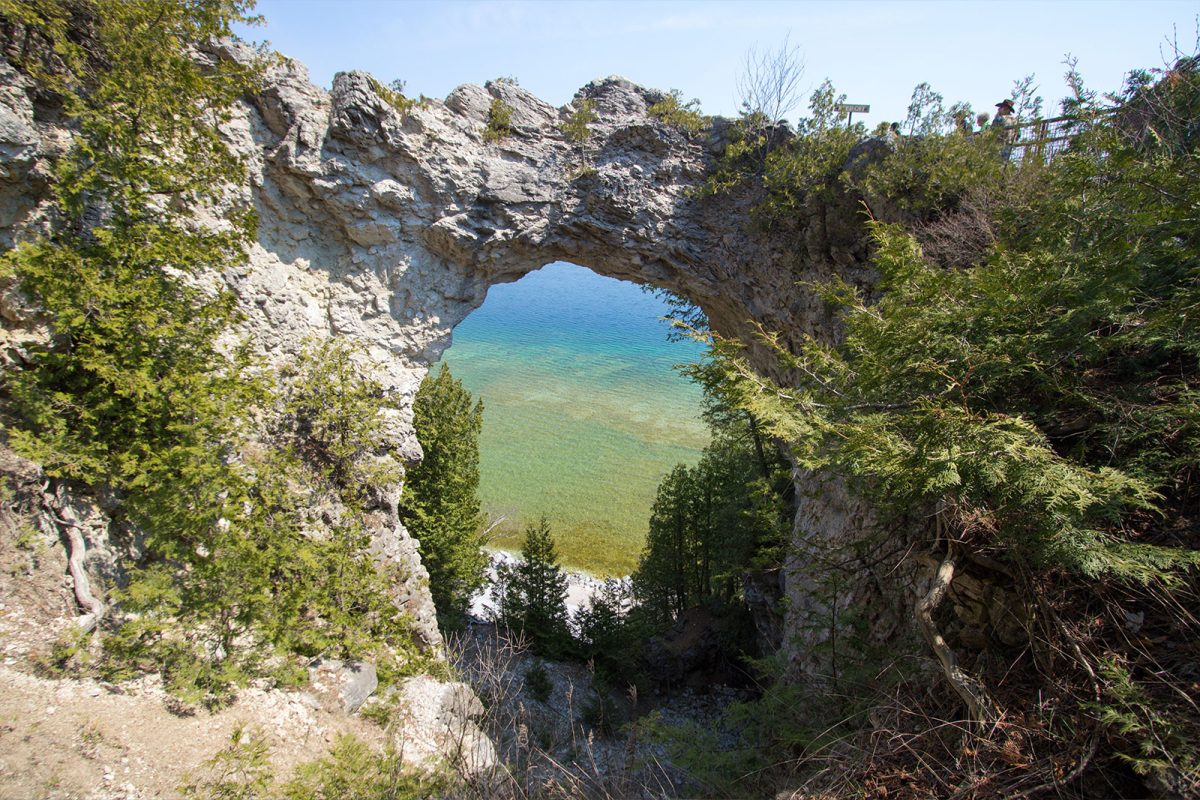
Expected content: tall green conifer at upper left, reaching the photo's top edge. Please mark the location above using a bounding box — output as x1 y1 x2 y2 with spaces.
0 1 258 492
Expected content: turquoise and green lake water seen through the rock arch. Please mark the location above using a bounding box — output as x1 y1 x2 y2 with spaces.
443 261 708 575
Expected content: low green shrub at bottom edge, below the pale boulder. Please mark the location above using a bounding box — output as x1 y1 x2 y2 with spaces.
280 734 452 800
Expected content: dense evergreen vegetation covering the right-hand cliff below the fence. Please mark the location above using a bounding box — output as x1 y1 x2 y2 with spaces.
657 48 1200 798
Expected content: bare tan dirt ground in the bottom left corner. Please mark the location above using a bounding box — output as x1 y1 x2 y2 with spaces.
0 667 380 800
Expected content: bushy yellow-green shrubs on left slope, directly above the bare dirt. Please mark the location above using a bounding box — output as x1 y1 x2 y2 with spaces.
104 344 427 705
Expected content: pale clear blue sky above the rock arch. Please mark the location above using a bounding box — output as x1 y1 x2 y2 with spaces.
238 0 1200 125
